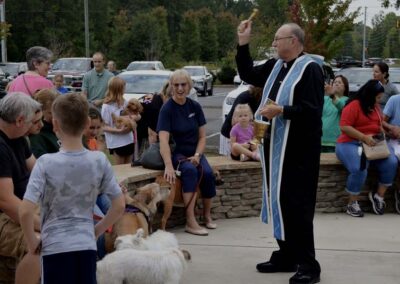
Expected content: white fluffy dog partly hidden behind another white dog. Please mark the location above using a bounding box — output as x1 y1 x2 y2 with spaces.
114 228 179 250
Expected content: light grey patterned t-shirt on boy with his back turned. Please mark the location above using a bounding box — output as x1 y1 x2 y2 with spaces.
24 150 122 255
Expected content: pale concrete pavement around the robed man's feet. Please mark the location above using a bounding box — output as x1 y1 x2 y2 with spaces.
171 213 400 284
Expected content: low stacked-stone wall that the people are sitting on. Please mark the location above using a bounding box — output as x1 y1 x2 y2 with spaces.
121 154 397 228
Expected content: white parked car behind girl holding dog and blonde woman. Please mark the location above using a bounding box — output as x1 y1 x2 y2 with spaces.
117 70 198 101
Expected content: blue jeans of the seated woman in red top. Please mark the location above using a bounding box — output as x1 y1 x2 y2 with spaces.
336 141 397 195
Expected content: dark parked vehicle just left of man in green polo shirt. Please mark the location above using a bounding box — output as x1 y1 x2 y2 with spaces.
47 57 93 92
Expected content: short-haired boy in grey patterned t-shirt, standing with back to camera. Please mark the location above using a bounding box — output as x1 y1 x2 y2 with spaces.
19 94 125 283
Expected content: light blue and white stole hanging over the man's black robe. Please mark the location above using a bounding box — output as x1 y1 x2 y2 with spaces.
255 55 314 240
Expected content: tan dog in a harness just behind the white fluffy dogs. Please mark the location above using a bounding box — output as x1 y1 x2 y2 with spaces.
105 183 168 253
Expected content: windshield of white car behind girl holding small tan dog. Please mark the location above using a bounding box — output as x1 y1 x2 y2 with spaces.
118 74 169 94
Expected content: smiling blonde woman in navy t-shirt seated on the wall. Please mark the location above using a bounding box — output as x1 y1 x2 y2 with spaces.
157 69 217 236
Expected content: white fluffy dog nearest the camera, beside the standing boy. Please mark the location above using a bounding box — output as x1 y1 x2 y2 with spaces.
97 248 186 284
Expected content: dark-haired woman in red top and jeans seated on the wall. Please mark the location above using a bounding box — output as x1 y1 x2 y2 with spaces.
336 80 397 217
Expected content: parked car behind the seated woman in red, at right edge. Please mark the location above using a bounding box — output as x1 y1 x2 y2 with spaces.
336 67 400 96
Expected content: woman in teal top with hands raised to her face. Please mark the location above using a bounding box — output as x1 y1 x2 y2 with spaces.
321 75 349 153
